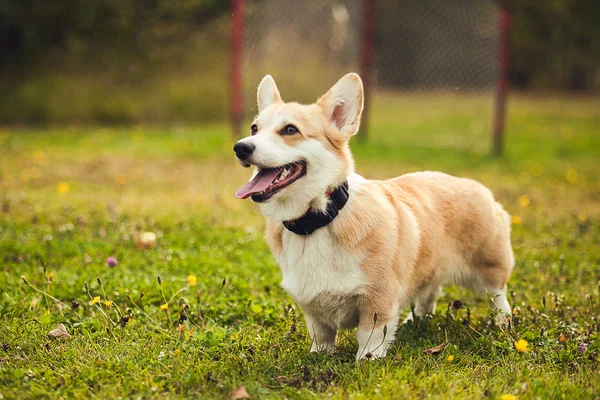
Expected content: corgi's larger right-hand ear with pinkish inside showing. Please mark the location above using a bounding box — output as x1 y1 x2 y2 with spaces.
317 74 364 137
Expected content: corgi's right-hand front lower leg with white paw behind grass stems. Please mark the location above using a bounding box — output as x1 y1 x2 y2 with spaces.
356 303 399 361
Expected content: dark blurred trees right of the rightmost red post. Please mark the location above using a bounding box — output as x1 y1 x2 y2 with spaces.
509 0 600 90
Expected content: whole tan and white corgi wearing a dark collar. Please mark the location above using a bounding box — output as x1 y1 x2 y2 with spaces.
234 73 514 360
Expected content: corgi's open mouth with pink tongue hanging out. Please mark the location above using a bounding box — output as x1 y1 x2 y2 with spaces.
235 161 306 203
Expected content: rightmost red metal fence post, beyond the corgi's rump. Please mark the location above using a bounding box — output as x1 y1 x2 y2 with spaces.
492 2 510 155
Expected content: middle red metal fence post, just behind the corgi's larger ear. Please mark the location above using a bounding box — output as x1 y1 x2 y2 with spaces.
358 0 375 141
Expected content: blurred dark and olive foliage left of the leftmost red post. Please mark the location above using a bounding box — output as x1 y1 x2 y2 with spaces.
0 0 229 124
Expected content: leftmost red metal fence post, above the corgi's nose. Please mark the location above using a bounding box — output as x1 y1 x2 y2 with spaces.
229 0 245 136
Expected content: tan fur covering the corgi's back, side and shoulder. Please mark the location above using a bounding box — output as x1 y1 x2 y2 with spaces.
332 172 512 324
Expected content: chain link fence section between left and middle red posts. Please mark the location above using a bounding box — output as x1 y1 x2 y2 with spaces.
243 0 361 117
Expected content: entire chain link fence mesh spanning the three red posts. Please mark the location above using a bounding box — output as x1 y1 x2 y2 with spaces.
237 0 501 150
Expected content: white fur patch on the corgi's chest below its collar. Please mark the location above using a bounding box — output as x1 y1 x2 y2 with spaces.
277 227 365 306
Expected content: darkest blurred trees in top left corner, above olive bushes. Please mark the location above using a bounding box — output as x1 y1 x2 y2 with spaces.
0 0 229 71
